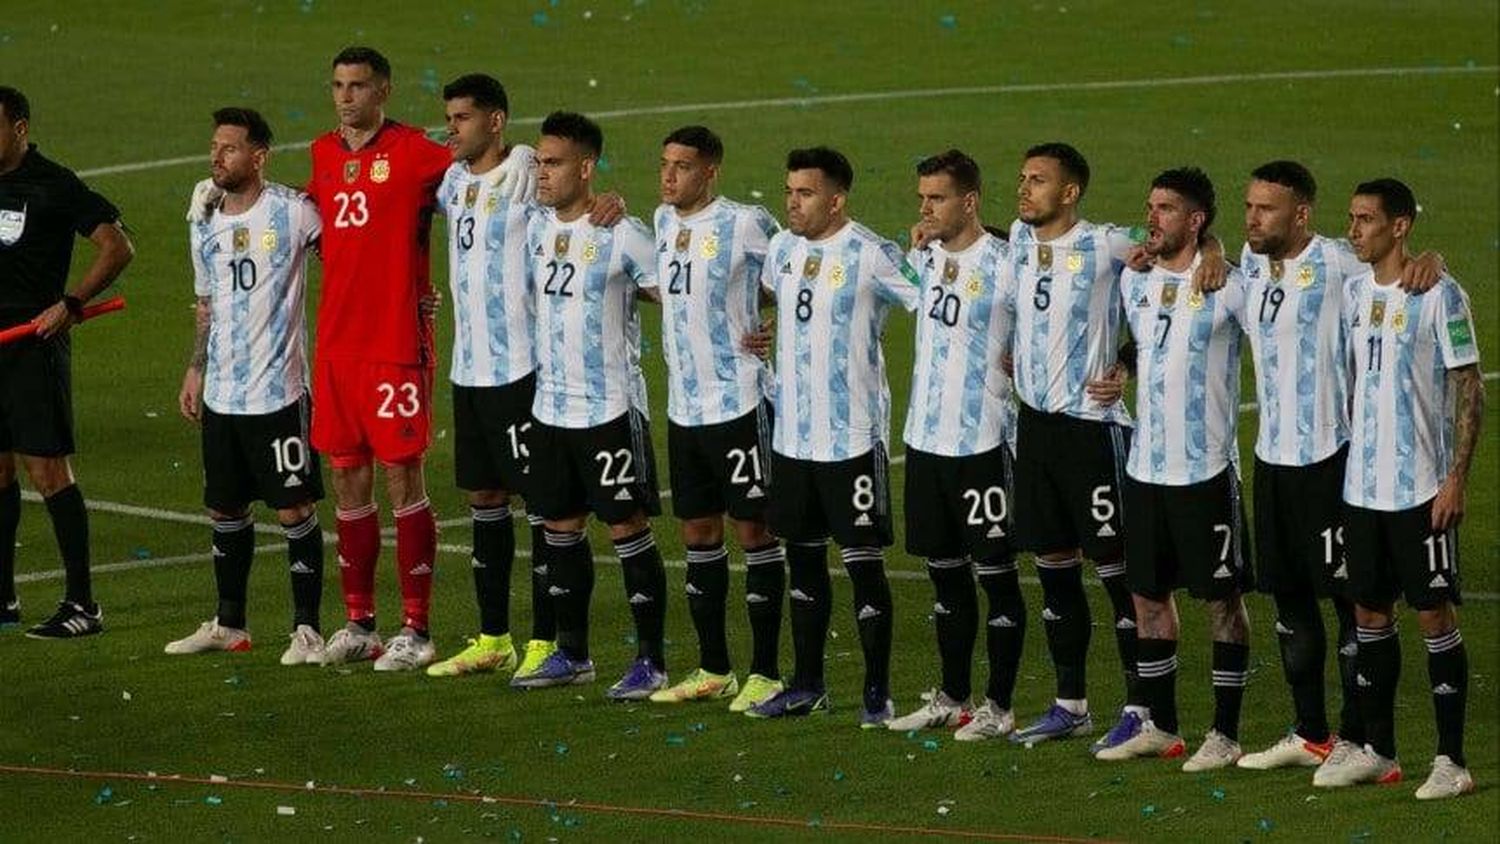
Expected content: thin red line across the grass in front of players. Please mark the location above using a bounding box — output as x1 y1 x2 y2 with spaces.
0 765 1106 844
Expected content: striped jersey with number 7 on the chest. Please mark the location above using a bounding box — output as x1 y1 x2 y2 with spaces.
1121 253 1245 486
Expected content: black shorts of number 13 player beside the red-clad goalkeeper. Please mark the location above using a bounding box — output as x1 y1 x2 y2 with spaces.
453 372 537 495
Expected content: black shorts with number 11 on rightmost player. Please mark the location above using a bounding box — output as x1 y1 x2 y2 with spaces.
1344 501 1463 610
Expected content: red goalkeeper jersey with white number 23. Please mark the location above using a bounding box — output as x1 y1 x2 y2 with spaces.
308 120 453 364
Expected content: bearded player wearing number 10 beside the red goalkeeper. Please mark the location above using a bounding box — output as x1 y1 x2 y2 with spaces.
174 108 324 666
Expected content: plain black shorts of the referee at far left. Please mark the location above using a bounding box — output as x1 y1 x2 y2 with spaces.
0 334 74 457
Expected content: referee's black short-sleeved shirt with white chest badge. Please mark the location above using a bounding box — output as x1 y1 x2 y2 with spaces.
0 144 120 328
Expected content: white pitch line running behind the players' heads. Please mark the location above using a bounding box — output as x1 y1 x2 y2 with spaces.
78 64 1500 178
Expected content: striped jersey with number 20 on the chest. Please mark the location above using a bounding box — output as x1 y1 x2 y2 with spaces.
905 232 1016 457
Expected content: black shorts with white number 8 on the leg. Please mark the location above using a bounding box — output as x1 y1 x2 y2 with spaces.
767 444 893 547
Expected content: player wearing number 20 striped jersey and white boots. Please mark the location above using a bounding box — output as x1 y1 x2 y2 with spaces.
890 150 1026 741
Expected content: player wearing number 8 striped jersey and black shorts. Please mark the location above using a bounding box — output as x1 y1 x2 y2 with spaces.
747 147 918 729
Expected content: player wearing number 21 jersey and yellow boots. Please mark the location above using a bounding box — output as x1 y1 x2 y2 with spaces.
651 126 786 712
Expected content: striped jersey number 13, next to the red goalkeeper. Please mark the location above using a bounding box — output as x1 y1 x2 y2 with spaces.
438 154 537 387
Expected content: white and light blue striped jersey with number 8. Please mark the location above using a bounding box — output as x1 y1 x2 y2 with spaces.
761 220 921 463
